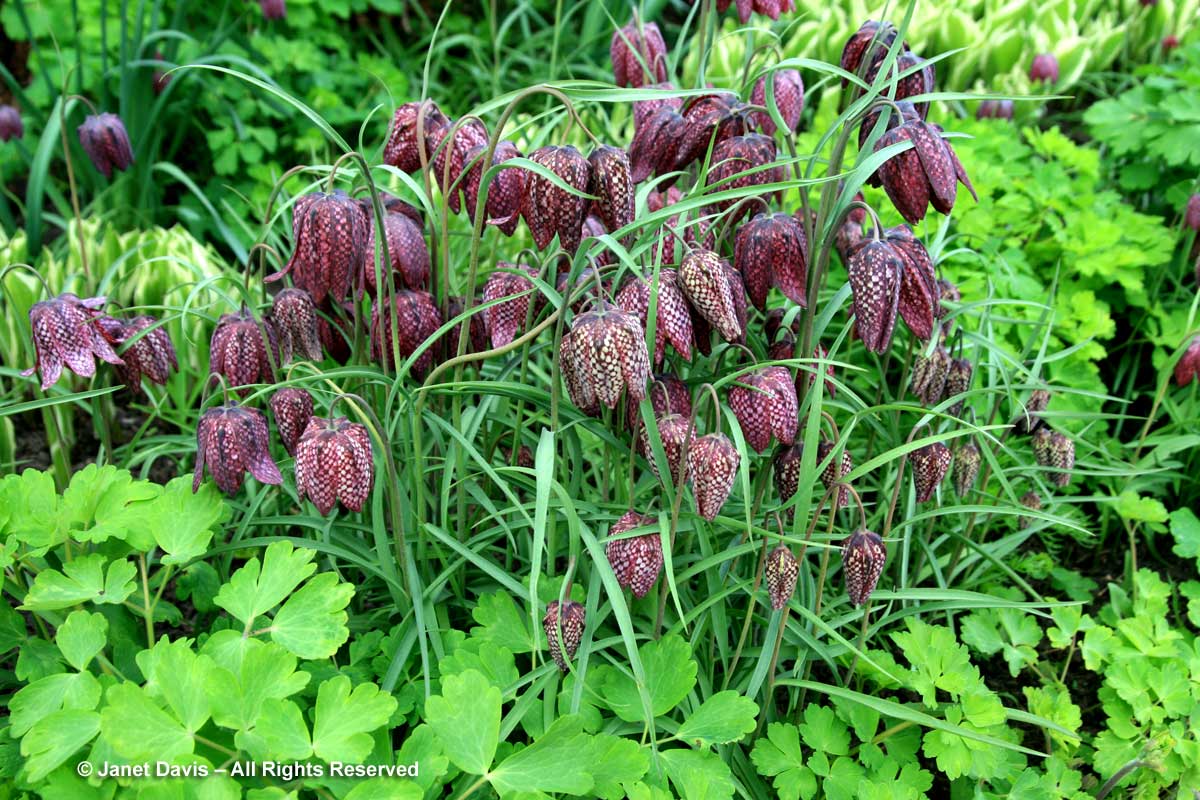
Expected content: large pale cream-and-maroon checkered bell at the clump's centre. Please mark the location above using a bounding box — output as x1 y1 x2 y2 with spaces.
560 301 650 411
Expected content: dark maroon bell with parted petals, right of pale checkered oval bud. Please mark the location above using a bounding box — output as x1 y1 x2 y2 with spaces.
733 213 809 311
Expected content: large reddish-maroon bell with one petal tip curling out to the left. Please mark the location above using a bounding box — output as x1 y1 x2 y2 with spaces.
266 190 371 303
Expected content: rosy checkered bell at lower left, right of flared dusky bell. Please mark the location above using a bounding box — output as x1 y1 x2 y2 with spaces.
295 416 374 516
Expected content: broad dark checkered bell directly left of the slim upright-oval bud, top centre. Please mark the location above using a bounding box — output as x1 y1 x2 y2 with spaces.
521 145 592 253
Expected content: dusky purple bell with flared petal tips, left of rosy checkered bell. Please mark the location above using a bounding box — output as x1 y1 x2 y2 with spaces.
192 403 283 494
